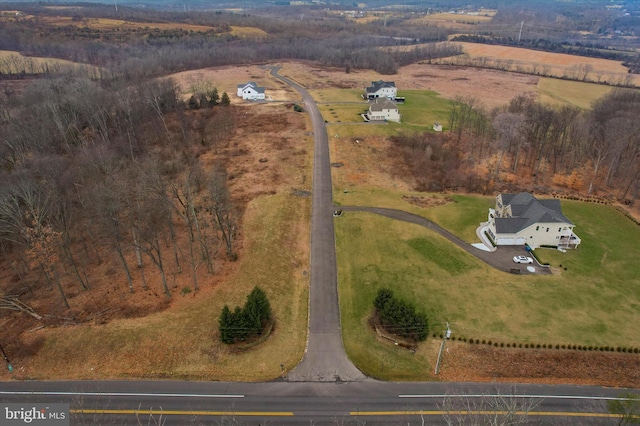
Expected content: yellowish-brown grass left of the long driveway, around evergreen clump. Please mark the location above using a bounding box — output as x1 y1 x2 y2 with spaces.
20 194 310 381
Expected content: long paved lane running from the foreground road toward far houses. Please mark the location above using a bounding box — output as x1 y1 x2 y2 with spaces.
270 67 366 382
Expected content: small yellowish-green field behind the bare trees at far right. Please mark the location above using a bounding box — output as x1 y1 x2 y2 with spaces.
537 78 613 109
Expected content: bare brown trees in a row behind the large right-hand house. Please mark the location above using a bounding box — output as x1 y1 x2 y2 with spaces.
392 89 640 204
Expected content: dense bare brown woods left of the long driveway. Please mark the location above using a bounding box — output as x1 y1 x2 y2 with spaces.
0 70 237 307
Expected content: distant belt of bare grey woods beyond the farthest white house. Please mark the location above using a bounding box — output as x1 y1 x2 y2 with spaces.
0 5 460 81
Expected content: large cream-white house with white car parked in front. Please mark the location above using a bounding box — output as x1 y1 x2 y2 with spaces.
486 192 581 249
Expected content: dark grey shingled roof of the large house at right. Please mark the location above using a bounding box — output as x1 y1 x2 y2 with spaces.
495 192 573 234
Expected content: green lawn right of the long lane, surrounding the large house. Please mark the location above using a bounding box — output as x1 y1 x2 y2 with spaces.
336 198 640 380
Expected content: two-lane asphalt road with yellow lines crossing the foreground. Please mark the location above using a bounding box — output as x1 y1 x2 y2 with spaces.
0 381 624 425
